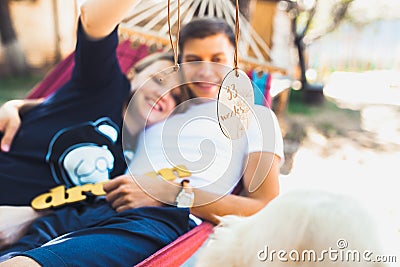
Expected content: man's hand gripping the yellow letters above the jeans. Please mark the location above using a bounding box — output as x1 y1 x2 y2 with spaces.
103 175 161 212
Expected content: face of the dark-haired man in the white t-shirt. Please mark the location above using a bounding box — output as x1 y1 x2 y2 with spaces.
182 33 235 98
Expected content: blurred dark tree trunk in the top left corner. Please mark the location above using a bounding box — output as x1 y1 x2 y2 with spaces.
0 0 29 74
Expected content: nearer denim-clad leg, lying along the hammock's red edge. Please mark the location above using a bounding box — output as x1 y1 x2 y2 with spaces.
7 207 189 267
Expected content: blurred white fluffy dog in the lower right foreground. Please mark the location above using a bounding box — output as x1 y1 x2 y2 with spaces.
196 191 385 267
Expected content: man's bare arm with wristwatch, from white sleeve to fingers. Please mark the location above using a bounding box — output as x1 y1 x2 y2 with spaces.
104 152 280 223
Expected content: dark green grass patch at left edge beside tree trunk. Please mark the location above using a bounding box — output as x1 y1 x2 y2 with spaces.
0 73 43 104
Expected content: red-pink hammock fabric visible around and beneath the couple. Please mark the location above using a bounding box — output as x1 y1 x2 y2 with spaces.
27 40 213 267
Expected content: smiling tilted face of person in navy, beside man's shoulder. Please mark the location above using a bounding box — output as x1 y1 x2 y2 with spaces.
125 60 180 129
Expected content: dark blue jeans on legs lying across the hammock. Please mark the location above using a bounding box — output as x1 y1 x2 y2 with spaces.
0 200 194 267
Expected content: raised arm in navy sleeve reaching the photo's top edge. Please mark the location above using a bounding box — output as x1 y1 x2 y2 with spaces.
71 0 139 92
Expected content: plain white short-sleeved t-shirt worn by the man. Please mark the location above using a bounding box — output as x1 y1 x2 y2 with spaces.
129 101 284 195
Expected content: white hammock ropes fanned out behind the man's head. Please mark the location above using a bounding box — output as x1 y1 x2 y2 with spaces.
120 0 285 72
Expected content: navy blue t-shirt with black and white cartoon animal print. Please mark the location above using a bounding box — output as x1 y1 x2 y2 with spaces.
0 25 130 205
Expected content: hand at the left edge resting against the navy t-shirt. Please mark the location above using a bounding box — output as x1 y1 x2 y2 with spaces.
0 100 23 152
